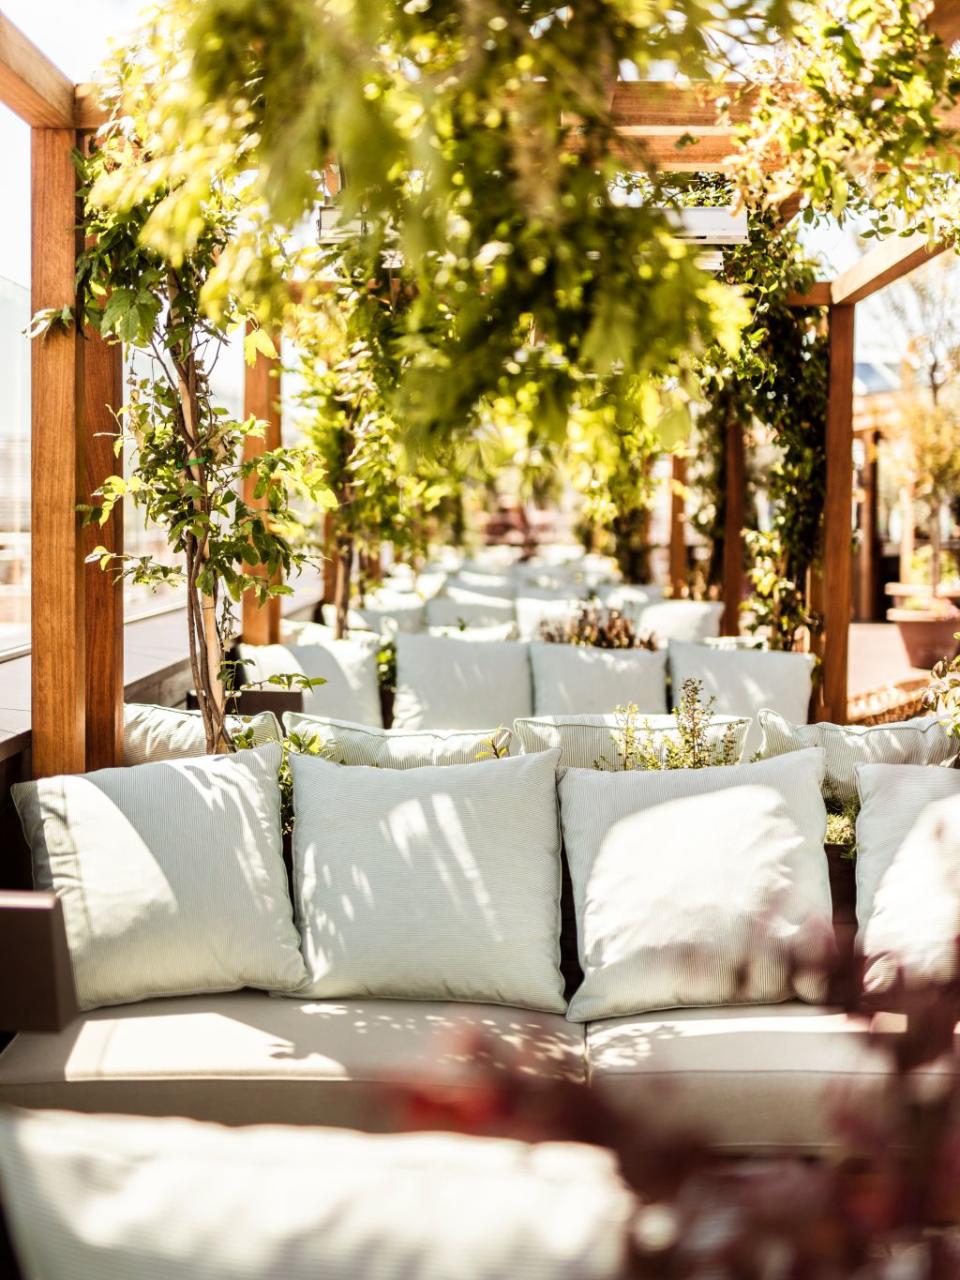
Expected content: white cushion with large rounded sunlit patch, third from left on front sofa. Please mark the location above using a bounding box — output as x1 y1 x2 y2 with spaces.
560 750 832 1021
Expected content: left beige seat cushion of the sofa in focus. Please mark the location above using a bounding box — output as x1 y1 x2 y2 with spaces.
0 991 585 1132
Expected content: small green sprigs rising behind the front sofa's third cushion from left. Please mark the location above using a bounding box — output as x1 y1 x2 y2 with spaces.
596 680 740 769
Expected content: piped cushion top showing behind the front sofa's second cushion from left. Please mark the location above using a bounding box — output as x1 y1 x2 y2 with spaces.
283 712 512 769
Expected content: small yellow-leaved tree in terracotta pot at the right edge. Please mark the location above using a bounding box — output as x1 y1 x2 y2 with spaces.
887 388 960 668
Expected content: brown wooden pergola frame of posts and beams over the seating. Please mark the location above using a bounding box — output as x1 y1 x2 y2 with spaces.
0 3 960 777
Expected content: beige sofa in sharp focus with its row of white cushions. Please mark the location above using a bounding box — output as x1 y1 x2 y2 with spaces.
0 713 960 1155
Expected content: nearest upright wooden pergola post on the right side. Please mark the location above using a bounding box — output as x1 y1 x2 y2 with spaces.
817 306 854 724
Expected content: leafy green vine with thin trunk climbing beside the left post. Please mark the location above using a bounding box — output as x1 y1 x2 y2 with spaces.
56 24 332 751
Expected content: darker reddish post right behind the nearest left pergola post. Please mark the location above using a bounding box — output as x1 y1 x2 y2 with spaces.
82 329 123 769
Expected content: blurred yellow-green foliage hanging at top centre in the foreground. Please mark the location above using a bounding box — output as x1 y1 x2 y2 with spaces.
116 0 773 455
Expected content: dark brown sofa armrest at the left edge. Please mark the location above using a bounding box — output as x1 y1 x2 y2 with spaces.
0 890 78 1032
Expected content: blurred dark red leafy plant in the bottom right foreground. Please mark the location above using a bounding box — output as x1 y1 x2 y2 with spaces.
397 946 960 1280
